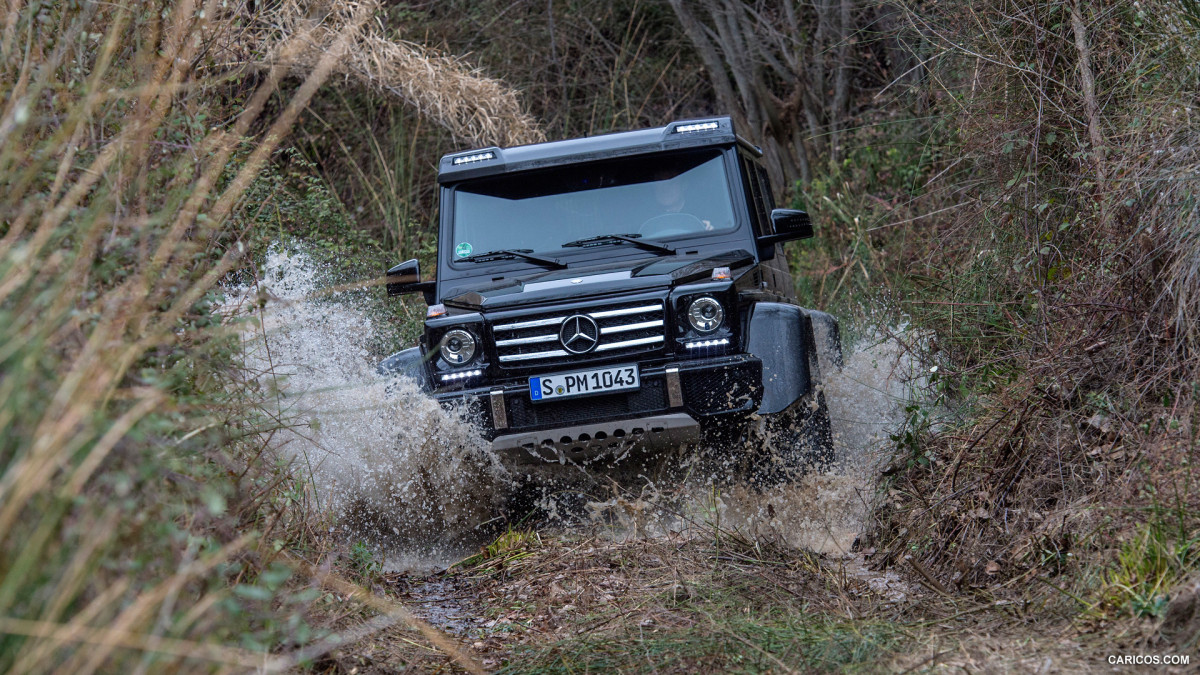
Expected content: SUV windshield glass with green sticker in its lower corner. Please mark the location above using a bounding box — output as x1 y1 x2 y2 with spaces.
451 149 737 259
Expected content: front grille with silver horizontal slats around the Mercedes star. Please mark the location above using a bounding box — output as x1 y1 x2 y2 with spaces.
492 300 666 368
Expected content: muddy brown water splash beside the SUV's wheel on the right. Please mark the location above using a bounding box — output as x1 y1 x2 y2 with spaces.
589 338 918 557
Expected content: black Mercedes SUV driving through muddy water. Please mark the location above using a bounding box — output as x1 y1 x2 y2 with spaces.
380 118 841 462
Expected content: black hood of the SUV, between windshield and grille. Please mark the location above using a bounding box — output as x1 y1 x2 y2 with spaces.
442 250 754 311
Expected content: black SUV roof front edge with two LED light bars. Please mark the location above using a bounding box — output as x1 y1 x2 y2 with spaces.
438 117 762 184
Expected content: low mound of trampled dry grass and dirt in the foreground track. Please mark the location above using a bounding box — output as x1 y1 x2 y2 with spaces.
326 526 1141 673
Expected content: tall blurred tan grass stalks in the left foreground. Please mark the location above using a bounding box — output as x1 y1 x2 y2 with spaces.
0 0 504 674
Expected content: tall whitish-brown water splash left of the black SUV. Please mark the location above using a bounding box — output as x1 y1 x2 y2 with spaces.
226 247 508 568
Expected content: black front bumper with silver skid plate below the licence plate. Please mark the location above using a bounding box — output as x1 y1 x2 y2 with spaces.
434 354 762 461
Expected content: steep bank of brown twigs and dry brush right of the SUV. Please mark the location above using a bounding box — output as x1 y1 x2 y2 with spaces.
875 0 1200 607
